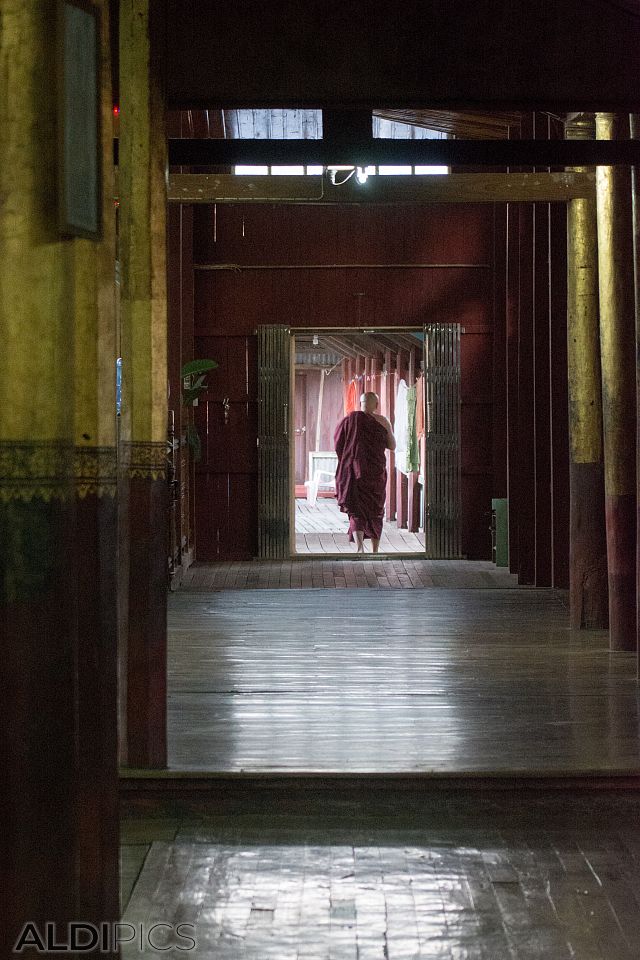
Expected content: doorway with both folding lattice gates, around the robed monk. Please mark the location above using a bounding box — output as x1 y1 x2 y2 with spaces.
252 323 462 559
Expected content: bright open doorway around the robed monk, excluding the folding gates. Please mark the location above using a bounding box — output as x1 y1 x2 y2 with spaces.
291 328 426 556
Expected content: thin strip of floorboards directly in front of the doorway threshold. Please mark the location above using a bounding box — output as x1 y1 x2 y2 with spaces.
180 554 518 593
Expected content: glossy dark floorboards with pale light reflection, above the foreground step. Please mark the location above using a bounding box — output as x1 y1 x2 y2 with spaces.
168 588 640 775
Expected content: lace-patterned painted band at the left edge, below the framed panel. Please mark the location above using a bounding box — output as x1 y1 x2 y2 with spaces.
0 440 117 503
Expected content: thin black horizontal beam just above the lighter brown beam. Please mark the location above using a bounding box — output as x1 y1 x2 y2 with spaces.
161 137 640 167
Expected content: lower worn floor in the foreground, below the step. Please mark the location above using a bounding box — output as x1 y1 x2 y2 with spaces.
122 792 640 960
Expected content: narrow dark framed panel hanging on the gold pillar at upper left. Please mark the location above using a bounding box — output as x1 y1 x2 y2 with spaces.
57 0 102 240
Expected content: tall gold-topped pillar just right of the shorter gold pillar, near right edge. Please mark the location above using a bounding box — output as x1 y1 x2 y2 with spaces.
596 113 637 650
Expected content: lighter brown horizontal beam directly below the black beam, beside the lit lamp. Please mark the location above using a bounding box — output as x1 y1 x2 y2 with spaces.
168 172 596 204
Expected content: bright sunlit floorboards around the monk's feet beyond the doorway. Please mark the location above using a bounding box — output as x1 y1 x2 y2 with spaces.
295 497 424 555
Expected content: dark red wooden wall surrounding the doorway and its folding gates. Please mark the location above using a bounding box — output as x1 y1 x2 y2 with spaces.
193 204 494 560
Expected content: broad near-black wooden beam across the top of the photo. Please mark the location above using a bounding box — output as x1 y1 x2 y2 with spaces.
164 0 640 113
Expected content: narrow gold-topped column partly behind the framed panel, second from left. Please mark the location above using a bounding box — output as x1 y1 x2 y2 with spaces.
70 0 119 921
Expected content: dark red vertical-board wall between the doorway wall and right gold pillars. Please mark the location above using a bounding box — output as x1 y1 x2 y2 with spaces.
494 113 569 588
